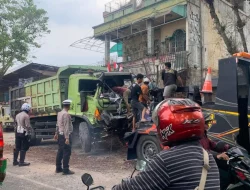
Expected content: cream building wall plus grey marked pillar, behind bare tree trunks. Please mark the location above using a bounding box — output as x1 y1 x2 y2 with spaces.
186 0 250 85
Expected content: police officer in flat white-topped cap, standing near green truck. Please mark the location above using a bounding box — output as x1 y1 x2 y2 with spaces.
54 100 74 175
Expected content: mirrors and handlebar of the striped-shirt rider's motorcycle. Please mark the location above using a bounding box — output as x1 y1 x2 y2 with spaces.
81 160 147 190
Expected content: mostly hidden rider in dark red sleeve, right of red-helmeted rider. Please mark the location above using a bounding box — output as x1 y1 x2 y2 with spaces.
200 125 230 190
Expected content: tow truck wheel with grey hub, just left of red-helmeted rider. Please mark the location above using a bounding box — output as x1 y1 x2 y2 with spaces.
136 135 161 162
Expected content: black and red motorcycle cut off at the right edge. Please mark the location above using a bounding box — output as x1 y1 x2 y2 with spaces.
223 147 250 190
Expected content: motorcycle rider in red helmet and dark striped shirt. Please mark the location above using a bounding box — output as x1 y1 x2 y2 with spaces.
113 99 220 190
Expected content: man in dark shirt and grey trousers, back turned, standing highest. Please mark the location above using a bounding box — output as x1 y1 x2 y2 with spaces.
162 62 183 99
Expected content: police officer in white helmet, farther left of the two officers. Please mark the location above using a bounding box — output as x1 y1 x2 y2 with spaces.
13 103 31 166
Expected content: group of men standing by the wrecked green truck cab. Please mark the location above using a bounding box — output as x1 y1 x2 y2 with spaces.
112 62 183 130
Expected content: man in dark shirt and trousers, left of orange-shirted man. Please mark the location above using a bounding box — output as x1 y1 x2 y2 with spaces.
131 74 144 127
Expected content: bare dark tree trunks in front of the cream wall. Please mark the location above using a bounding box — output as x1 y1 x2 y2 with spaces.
205 0 248 55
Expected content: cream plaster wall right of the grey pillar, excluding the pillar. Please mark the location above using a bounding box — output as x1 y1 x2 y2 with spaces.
201 0 250 77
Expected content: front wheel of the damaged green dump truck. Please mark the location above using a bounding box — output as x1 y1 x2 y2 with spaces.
79 122 91 153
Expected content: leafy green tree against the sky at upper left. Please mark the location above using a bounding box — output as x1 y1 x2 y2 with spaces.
0 0 50 79
